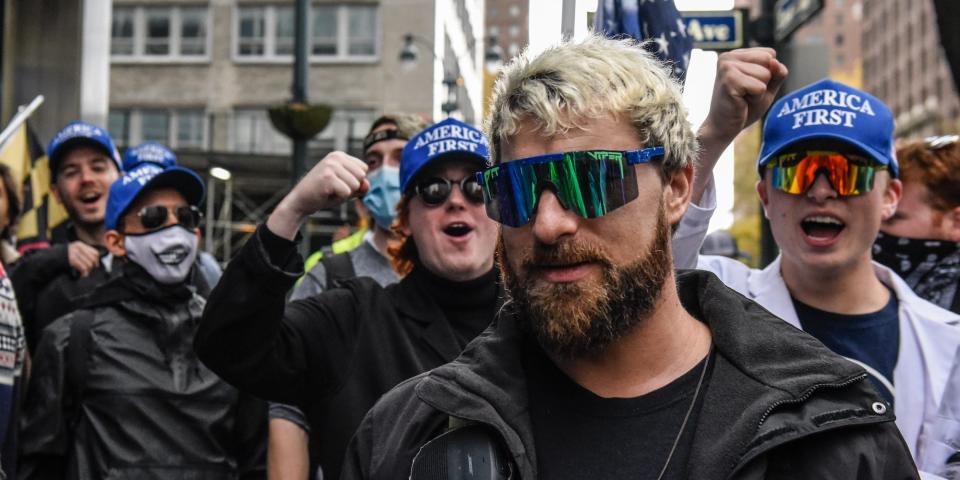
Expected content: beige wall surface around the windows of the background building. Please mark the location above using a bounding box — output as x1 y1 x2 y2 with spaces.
110 0 442 151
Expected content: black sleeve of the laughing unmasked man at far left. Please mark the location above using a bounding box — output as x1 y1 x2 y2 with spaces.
7 244 70 346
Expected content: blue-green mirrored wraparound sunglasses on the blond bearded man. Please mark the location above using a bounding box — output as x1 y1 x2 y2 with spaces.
477 147 664 227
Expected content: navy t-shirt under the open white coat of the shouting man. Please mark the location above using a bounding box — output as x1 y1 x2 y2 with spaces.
793 292 900 405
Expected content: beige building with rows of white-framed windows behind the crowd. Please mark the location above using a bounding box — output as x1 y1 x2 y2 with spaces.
108 0 484 258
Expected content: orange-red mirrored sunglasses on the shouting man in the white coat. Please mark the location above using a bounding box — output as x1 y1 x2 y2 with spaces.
767 150 887 197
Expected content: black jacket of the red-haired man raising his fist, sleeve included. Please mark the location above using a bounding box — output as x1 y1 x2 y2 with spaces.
195 227 494 478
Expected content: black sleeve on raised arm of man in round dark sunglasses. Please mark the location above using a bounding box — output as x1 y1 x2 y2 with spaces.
194 226 360 405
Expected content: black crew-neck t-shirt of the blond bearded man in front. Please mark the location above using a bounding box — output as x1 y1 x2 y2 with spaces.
524 346 713 480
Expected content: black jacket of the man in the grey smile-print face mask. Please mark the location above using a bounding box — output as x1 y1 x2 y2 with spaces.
19 263 267 480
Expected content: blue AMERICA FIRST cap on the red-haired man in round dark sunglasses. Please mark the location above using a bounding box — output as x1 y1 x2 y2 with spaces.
400 118 490 192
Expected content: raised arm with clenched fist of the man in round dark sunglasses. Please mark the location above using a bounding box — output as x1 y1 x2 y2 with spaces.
194 152 368 405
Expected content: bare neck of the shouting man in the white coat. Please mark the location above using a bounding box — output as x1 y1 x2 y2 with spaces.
780 252 890 315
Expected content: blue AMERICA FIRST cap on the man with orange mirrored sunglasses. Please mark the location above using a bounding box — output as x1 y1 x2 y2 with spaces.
757 79 900 177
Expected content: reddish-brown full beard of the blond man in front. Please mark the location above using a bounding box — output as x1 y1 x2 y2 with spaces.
497 207 673 359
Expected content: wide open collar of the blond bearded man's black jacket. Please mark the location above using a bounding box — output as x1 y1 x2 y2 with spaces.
416 270 892 478
